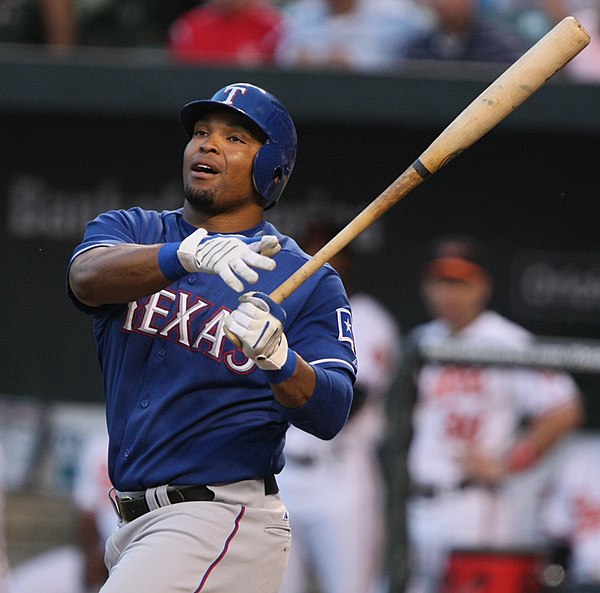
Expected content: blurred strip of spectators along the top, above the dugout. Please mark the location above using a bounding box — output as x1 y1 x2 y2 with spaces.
0 0 600 82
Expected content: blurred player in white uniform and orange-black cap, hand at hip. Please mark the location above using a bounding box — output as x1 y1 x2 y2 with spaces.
387 238 582 593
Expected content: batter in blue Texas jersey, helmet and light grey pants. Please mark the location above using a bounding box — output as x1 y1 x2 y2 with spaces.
68 83 356 593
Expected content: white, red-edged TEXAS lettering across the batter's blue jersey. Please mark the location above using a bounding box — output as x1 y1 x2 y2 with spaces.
122 288 254 373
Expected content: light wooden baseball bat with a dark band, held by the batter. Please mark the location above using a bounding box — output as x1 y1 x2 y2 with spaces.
228 16 590 347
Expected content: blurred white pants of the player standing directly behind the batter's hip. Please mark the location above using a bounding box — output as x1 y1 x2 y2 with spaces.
278 449 383 593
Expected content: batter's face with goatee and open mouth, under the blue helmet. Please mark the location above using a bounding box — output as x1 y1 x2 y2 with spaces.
183 111 263 214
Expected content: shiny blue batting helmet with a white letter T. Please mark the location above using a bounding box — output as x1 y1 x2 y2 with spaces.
179 82 298 209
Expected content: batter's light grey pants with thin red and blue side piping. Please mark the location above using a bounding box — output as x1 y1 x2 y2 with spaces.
101 480 291 593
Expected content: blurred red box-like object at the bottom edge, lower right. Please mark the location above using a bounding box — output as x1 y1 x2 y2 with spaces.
440 548 546 593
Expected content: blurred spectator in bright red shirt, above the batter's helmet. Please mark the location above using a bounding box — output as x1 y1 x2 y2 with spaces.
167 0 281 66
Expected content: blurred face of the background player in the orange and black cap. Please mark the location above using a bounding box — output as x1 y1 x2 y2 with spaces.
423 275 491 331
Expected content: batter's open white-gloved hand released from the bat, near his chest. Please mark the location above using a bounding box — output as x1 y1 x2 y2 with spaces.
177 229 281 292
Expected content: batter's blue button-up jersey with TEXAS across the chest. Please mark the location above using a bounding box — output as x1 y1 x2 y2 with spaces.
69 208 356 491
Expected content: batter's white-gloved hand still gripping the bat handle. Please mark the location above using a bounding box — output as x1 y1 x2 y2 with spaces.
224 292 288 371
